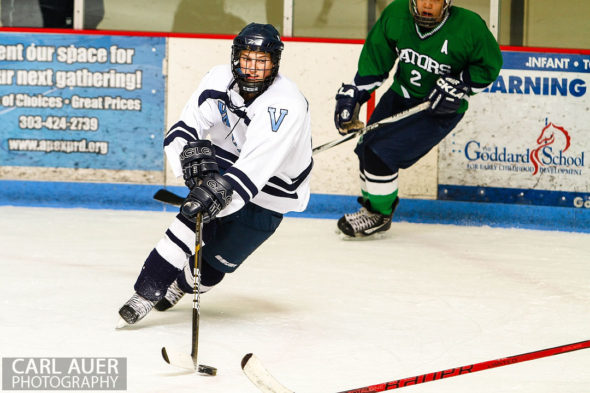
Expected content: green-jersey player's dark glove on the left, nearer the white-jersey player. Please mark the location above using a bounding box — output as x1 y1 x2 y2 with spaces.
334 84 371 135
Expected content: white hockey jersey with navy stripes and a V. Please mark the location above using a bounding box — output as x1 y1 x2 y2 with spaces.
164 64 313 217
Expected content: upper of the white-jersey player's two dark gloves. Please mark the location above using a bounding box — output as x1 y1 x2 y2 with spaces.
180 139 219 190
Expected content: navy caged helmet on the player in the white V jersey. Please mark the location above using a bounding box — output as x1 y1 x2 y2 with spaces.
231 23 284 95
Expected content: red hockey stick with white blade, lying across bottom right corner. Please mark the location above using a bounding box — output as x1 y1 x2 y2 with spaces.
242 340 590 393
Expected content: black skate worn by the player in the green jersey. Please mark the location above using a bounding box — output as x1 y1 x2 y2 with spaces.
338 197 399 237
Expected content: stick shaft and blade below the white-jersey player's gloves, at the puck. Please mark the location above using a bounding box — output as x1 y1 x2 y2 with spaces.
162 213 217 376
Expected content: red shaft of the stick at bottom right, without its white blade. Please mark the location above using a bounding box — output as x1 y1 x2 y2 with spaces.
339 340 590 393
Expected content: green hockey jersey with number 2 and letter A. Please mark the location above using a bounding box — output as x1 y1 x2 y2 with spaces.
355 0 502 112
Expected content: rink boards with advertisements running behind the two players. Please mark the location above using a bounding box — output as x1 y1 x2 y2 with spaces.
0 31 590 230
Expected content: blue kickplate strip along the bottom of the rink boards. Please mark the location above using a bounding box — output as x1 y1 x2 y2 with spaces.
0 180 590 233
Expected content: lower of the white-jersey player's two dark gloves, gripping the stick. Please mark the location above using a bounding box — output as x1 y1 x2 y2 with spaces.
180 173 233 223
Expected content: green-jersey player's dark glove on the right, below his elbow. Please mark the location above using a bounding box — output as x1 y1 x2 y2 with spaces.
428 76 471 115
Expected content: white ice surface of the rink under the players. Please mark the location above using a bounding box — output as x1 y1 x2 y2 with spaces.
0 206 590 393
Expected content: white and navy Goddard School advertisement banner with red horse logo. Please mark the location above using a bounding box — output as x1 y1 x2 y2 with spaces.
438 51 590 207
